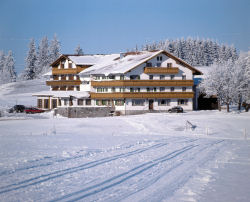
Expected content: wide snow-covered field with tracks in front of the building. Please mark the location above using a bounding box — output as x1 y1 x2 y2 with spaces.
0 79 250 201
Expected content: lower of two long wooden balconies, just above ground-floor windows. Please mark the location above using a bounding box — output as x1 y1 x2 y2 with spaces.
90 92 194 99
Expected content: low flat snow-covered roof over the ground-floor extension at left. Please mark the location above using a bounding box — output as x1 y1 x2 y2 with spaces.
32 91 89 98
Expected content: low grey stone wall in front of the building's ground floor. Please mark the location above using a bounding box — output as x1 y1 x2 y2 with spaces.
55 107 114 118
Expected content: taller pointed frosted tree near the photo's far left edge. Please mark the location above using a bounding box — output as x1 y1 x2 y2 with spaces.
2 51 16 83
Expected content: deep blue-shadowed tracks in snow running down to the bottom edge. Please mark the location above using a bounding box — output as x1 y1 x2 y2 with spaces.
50 140 223 202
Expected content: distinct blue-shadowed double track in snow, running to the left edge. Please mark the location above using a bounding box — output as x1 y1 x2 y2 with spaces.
0 140 178 194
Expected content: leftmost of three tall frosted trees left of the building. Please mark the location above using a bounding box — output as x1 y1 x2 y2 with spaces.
21 39 37 80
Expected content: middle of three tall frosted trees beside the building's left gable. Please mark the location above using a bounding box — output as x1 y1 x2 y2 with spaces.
35 37 50 78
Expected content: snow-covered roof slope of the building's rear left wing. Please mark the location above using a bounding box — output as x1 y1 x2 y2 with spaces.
68 54 120 65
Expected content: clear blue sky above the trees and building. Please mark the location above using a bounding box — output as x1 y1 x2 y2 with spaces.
0 0 250 73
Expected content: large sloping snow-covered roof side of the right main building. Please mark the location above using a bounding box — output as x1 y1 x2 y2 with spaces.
80 50 162 75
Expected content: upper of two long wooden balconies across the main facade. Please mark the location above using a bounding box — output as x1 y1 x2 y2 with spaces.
91 80 194 87
